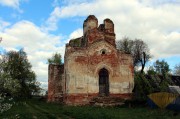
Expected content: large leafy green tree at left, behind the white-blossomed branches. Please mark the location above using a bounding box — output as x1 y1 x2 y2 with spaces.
2 49 40 97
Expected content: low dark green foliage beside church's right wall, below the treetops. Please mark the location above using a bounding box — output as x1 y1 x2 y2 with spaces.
133 71 173 101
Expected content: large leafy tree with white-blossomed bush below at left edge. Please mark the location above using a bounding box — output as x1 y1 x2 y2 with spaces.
0 45 40 113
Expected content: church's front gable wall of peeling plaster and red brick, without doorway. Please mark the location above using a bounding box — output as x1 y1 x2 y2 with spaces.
65 41 134 104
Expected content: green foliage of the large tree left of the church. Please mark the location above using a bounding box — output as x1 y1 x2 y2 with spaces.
0 49 40 97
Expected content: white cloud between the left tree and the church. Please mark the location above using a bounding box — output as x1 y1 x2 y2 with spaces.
0 20 65 89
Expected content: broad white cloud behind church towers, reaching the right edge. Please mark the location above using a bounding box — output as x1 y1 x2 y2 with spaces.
46 0 180 58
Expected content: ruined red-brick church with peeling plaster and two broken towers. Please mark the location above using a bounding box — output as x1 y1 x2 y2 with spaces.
48 15 134 105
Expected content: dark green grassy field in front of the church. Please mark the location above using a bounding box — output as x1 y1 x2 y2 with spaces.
0 99 180 119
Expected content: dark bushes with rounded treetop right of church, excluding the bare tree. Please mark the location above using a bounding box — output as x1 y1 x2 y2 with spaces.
134 60 174 101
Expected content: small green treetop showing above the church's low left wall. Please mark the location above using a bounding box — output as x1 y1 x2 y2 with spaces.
48 53 62 64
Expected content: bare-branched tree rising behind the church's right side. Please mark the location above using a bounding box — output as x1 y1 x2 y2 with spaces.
117 37 151 73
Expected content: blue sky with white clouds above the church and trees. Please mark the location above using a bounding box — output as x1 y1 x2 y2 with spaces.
0 0 180 89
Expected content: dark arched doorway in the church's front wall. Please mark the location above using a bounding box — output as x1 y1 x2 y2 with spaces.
99 68 109 96
